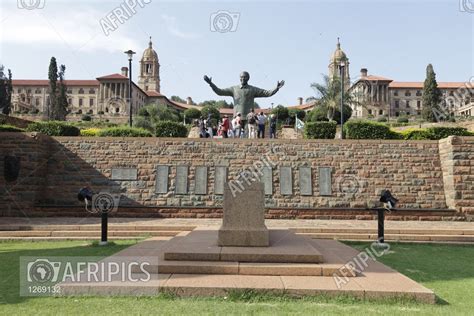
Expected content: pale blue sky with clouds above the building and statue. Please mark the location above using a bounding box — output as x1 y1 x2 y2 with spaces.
0 0 474 107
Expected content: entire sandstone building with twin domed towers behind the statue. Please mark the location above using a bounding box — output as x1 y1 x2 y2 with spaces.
12 38 474 119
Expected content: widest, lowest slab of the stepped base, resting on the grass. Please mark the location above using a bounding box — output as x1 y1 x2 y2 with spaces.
60 231 435 304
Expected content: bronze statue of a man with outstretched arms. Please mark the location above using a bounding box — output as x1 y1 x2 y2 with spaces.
204 71 285 120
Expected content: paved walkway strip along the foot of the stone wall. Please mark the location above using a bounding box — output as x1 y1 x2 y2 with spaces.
0 217 474 230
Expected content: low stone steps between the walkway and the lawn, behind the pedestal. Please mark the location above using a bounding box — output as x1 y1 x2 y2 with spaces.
0 224 474 244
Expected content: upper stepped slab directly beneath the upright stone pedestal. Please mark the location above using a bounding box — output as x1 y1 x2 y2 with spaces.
164 230 324 263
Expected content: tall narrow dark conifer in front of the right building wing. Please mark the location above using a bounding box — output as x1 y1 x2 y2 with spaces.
421 64 444 122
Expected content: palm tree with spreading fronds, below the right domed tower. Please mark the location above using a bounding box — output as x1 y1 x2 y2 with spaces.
307 75 355 123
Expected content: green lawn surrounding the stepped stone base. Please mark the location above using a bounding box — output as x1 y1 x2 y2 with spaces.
0 241 474 315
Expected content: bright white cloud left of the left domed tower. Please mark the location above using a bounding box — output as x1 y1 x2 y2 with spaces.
0 2 143 52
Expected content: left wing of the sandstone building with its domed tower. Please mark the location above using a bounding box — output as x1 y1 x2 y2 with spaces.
12 38 195 123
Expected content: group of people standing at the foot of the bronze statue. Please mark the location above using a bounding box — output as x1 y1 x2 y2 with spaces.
199 109 277 138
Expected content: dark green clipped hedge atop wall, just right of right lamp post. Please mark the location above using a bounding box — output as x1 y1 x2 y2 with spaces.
344 120 402 139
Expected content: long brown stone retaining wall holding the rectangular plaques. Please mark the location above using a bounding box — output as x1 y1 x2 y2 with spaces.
0 133 474 219
